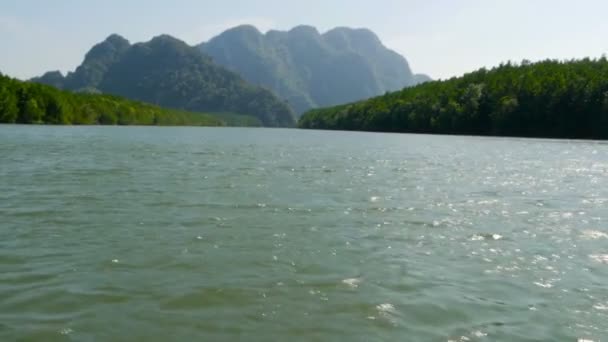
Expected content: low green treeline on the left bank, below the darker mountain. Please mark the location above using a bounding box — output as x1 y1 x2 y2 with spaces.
0 75 226 126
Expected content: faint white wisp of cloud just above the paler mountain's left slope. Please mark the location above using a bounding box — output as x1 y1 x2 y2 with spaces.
178 17 276 45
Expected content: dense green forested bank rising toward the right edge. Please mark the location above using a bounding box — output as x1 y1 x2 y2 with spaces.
299 58 608 139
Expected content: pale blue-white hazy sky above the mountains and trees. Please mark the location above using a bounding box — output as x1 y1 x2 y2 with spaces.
0 0 608 79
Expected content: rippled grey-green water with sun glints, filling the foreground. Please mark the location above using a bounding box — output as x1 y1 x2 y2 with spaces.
0 126 608 341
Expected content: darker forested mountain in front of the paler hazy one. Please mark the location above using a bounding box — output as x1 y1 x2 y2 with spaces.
32 34 295 126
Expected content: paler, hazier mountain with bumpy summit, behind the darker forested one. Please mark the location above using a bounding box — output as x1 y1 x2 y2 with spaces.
198 25 428 113
